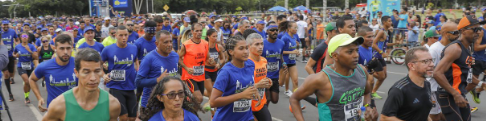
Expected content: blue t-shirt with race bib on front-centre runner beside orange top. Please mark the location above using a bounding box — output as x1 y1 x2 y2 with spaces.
213 59 255 121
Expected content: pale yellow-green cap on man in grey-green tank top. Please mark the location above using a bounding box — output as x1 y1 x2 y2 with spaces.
327 34 364 57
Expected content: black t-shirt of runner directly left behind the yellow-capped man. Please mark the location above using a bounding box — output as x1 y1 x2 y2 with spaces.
311 40 327 72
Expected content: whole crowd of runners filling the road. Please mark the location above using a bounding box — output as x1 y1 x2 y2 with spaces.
0 5 486 121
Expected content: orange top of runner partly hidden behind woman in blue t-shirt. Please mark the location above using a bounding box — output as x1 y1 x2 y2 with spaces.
250 56 267 111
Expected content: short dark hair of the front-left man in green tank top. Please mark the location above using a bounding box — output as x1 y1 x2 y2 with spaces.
75 47 101 71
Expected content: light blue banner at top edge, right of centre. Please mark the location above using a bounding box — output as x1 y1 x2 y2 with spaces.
368 0 401 21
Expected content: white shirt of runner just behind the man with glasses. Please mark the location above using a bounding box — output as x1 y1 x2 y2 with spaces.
425 42 445 92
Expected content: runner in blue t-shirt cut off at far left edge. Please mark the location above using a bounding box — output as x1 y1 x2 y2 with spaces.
1 20 19 101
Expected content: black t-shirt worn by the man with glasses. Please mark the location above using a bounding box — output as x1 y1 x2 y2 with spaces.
381 75 432 121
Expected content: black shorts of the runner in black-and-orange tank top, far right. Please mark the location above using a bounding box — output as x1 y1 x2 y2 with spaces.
437 89 471 121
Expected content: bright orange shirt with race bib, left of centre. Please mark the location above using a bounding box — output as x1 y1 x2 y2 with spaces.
181 39 209 82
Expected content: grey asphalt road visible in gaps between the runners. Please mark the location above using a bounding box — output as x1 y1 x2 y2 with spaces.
0 62 486 121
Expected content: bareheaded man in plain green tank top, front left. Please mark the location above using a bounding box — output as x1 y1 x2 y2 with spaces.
43 48 121 121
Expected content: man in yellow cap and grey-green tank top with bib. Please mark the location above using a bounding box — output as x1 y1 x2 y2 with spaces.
289 34 378 121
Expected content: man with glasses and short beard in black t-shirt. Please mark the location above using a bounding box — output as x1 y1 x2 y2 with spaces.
381 47 434 121
